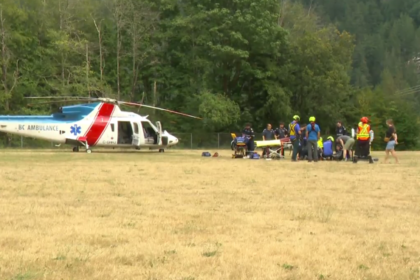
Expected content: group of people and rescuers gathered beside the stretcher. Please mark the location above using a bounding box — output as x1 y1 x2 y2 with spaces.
242 115 398 163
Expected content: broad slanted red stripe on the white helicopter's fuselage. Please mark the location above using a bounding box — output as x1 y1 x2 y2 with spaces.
86 103 115 146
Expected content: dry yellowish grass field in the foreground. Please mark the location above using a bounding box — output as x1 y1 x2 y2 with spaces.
0 150 420 280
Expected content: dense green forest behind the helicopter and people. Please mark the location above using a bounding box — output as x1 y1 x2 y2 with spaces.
0 0 420 148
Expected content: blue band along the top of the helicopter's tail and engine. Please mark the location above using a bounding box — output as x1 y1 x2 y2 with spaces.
0 103 101 123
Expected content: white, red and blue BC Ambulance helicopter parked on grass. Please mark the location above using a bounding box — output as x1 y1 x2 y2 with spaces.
0 97 201 153
